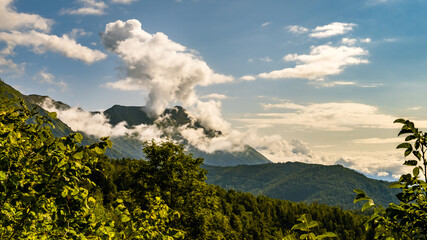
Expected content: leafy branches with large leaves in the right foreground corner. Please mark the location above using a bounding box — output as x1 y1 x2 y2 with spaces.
354 119 427 239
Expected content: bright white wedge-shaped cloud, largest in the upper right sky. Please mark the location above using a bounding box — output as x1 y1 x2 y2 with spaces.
258 45 369 81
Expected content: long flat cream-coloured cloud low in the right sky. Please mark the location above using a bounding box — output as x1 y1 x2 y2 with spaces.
236 102 427 131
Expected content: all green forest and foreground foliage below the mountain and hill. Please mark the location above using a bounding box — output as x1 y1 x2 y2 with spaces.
0 95 427 239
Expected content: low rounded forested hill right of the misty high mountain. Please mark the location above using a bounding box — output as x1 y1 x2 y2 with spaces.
203 162 398 209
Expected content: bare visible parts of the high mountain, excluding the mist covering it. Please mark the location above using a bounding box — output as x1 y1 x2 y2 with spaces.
0 80 270 166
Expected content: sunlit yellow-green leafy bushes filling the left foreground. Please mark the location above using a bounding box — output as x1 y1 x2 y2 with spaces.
0 99 182 239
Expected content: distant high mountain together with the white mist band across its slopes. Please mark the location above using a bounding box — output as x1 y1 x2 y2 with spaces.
1 82 270 166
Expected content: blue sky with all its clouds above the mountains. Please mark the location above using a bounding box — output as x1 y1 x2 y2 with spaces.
0 0 427 180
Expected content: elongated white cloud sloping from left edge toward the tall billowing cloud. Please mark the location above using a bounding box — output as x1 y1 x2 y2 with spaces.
0 30 107 64
